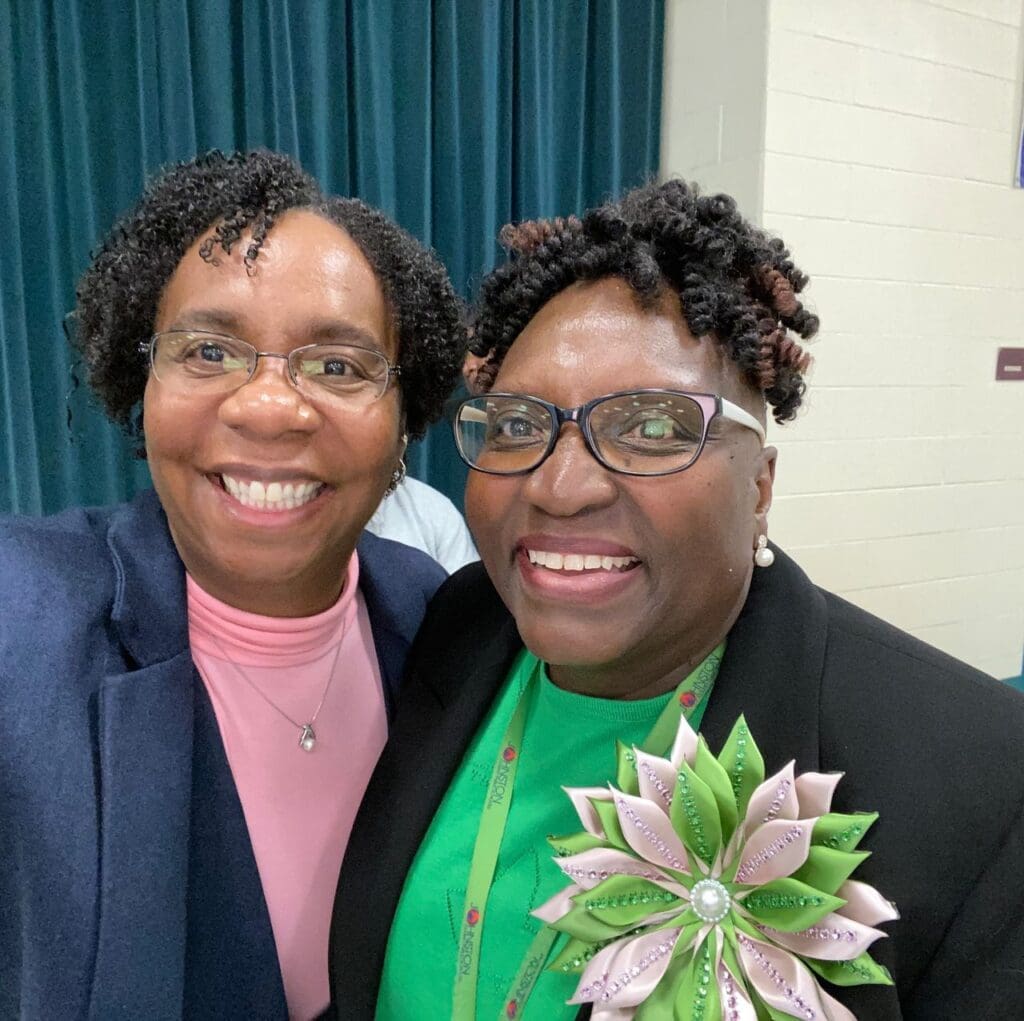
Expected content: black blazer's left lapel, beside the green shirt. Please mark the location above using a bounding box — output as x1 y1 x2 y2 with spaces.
330 619 521 1021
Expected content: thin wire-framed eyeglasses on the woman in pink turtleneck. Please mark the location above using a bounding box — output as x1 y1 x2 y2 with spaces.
139 330 401 406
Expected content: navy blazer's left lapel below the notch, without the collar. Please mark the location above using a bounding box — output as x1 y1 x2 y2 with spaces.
89 650 193 1021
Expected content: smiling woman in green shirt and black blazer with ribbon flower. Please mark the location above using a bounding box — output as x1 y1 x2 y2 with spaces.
331 181 1024 1021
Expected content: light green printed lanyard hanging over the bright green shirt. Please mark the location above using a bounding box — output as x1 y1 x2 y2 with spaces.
452 642 725 1021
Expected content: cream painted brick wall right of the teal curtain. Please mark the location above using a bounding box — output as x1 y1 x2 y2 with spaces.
663 0 1024 677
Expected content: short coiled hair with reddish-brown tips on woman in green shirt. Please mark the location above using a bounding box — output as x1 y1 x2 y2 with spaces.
469 180 818 422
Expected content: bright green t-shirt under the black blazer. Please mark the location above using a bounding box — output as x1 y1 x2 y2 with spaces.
377 646 722 1021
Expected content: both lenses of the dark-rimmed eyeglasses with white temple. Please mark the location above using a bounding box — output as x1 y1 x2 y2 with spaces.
456 391 705 475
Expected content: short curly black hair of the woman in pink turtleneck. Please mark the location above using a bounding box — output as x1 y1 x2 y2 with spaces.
72 150 466 438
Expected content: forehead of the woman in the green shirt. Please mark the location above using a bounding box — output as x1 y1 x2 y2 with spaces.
494 278 739 405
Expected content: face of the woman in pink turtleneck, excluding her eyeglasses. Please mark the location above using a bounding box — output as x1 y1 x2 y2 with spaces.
143 211 402 616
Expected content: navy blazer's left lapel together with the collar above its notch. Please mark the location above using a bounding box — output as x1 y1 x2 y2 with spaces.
89 493 194 1021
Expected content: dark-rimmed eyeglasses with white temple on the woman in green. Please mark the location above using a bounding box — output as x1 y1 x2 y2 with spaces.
453 389 765 475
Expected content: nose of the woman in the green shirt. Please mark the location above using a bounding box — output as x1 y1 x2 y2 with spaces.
523 422 618 517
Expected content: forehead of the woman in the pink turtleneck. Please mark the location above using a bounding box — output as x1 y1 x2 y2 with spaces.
156 204 395 354
